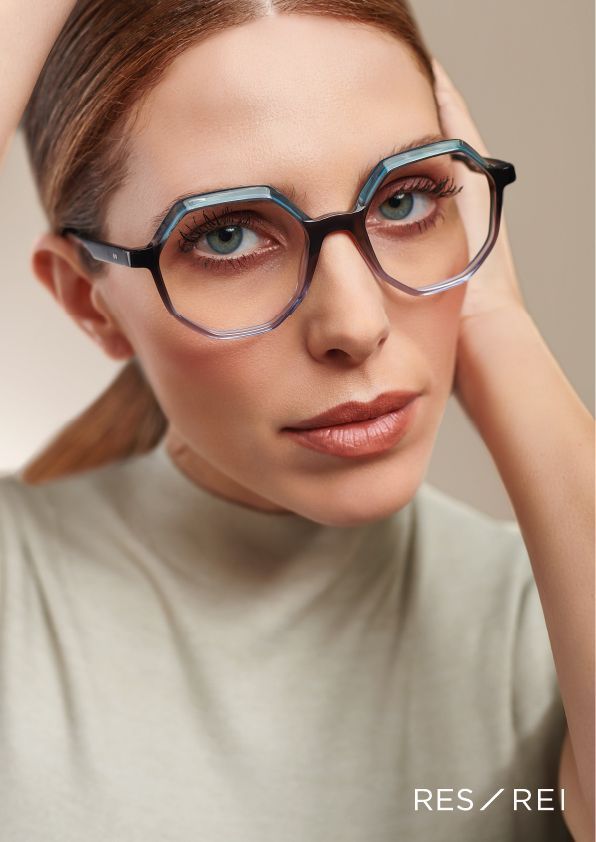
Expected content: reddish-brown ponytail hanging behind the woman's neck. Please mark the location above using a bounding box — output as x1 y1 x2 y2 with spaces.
20 358 167 484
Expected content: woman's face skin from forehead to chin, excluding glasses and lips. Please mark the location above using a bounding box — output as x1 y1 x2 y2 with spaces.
96 14 465 525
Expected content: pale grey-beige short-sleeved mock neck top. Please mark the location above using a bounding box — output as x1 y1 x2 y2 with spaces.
0 443 571 842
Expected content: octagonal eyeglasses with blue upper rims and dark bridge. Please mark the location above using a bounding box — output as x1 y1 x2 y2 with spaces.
60 139 516 339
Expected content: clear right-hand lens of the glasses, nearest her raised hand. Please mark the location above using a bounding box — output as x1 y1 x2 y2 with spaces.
366 148 491 289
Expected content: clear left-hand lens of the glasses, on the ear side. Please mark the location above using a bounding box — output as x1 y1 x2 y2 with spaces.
159 199 306 330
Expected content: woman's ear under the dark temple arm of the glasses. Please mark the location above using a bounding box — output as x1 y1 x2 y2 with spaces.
31 232 135 360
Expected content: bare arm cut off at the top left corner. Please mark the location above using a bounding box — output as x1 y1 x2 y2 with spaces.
0 0 75 164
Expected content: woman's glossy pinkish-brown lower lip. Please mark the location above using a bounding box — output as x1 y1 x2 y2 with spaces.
282 398 418 457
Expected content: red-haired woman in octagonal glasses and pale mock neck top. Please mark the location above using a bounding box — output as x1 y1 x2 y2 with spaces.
1 0 593 842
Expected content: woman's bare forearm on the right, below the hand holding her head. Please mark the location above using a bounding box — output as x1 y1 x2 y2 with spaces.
458 308 594 814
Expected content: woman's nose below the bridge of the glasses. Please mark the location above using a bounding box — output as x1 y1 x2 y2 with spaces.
297 231 390 363
